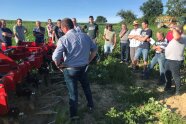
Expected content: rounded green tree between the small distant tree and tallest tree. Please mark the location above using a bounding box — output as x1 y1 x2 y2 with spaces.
116 9 136 23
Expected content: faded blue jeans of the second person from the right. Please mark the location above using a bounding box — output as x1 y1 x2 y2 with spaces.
148 53 165 83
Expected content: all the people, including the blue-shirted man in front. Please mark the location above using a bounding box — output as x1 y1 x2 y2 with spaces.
0 16 186 119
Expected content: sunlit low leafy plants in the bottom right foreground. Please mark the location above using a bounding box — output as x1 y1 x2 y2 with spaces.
106 98 186 124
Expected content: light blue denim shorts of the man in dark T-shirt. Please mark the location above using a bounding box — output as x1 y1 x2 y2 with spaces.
134 48 149 62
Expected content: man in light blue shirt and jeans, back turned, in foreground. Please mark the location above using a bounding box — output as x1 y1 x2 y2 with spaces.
52 18 97 119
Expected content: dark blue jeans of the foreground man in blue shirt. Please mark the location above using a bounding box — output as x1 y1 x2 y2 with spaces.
63 66 93 117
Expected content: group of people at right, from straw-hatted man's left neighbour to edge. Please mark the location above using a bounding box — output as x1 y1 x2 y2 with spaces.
119 20 186 95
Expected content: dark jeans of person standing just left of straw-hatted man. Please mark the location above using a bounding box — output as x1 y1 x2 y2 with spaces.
120 43 130 62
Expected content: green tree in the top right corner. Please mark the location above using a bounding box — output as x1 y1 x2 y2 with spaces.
166 0 186 17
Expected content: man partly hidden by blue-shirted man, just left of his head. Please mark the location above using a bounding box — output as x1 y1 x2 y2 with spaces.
52 19 64 42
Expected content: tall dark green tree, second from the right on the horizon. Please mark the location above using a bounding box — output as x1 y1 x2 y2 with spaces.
140 0 163 21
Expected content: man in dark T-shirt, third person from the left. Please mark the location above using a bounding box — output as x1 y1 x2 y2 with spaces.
33 21 45 43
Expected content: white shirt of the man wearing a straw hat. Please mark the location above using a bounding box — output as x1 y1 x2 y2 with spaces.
129 28 142 47
